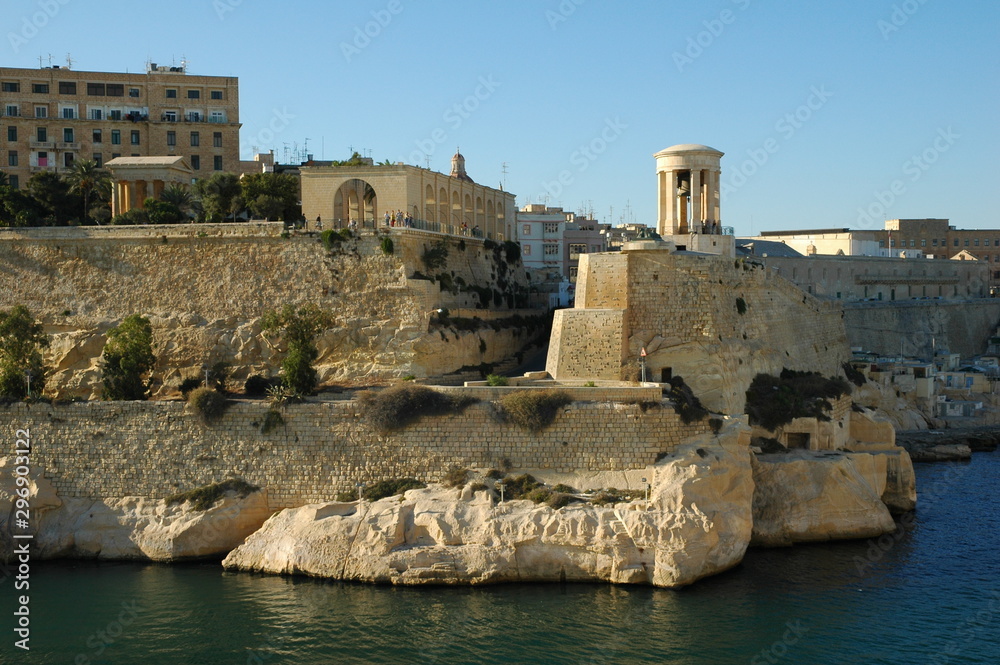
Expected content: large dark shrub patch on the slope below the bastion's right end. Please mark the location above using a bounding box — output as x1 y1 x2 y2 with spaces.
746 369 851 432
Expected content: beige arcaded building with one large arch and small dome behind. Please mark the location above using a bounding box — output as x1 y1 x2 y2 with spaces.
301 154 516 240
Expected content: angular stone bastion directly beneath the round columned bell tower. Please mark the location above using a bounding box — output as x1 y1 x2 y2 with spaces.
548 250 850 413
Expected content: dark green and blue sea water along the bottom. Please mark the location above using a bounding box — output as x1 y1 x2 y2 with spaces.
0 453 1000 665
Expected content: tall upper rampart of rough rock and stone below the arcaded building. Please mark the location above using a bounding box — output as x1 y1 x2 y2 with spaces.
0 224 531 397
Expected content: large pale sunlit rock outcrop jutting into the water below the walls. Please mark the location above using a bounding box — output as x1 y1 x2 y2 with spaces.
223 429 753 587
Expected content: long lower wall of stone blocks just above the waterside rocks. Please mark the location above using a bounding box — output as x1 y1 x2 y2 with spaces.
0 401 708 509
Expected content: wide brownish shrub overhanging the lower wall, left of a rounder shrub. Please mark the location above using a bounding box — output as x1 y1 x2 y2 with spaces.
358 383 478 434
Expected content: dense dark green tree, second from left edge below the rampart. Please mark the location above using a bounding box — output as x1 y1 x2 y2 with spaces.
102 314 156 400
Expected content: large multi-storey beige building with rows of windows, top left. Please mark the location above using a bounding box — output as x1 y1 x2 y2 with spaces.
0 64 240 187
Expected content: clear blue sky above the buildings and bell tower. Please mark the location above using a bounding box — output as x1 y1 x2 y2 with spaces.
0 0 1000 235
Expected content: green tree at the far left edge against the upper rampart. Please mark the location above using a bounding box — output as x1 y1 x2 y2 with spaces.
0 305 49 399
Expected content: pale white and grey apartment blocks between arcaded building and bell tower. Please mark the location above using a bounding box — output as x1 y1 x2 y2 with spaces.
517 203 610 283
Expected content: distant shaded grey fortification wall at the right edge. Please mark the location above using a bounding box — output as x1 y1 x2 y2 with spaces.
844 298 1000 358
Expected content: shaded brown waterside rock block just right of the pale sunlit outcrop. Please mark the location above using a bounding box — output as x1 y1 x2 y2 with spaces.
751 451 895 547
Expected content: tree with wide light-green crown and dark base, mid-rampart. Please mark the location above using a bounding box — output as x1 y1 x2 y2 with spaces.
261 303 333 395
